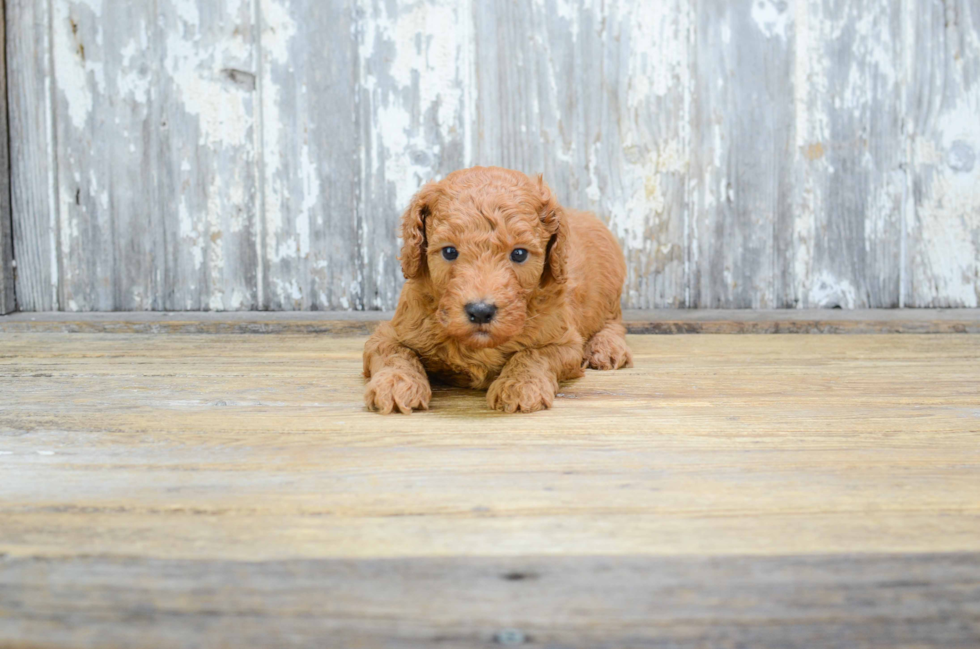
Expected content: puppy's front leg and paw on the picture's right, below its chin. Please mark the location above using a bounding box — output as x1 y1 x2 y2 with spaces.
487 344 584 412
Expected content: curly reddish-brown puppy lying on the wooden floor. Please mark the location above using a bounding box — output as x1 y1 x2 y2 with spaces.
364 167 633 414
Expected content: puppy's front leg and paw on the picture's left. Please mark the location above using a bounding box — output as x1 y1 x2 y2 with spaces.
364 324 432 415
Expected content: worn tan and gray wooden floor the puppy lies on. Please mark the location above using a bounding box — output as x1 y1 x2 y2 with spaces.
0 333 980 649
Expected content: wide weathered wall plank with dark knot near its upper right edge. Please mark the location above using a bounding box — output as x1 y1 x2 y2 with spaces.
39 1 256 311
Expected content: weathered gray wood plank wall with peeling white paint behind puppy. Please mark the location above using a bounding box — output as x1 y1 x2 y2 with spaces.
1 0 980 310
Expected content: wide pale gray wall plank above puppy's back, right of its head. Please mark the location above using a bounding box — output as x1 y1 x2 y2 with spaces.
474 0 694 308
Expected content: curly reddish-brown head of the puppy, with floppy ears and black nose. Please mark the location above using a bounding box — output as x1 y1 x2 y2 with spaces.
401 167 567 348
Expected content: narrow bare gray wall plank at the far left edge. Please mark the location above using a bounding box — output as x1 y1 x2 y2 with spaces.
6 0 61 311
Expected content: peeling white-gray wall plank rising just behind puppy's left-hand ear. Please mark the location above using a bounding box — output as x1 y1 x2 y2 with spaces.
356 0 474 309
